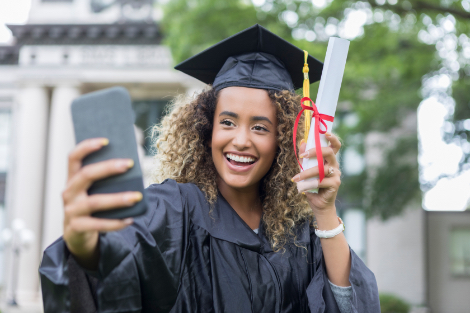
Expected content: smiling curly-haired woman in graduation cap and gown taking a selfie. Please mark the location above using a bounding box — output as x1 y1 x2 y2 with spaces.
40 25 380 313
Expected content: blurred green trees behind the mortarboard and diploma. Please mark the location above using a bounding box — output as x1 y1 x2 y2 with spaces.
162 0 470 219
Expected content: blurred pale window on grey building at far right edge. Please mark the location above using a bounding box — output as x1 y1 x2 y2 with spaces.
450 228 470 276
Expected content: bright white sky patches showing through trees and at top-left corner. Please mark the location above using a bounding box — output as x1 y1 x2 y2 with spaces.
0 0 470 211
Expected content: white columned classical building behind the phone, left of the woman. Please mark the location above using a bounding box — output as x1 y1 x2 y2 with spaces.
0 0 203 304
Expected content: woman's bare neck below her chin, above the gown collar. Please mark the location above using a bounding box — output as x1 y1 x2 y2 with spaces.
217 177 262 229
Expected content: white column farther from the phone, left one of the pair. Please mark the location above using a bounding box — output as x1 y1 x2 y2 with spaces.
5 86 49 304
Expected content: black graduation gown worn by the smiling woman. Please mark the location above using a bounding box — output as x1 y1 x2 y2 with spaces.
39 180 380 313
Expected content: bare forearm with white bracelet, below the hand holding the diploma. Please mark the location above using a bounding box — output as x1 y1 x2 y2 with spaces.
315 208 351 287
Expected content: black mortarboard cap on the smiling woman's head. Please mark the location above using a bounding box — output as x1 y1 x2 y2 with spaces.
175 24 323 90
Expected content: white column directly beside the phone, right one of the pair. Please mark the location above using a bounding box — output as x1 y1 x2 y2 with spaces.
42 85 80 250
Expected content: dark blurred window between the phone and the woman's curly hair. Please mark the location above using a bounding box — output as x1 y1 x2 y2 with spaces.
132 100 168 155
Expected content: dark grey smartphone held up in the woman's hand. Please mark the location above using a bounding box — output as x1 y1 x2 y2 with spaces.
72 87 147 219
